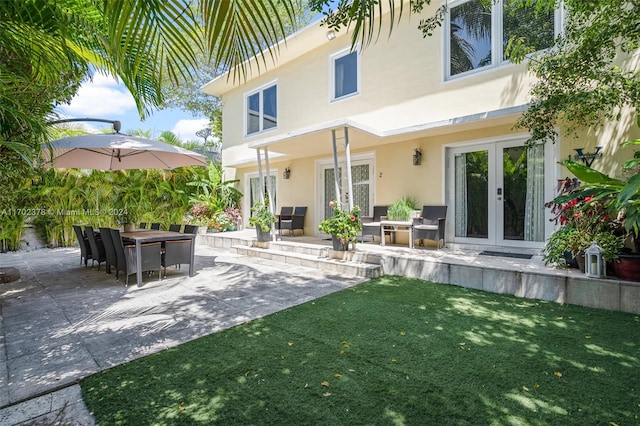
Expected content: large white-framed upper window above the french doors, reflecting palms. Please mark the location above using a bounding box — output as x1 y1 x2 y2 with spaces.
445 0 560 78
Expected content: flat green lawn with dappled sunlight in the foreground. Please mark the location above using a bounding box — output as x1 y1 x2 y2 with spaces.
82 276 640 425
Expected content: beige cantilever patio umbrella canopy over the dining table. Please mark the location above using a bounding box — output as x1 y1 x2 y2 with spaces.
42 133 207 170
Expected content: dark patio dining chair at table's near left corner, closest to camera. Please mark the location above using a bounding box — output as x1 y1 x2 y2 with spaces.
110 229 162 286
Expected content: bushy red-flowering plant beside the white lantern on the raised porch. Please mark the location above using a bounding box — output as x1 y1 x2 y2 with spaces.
542 180 624 265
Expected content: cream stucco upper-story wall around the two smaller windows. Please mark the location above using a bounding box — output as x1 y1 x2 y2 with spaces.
215 2 531 162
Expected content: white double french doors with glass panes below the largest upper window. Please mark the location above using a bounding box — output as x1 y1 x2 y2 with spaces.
447 139 552 247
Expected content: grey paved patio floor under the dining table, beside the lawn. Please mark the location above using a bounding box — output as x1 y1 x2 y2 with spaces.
0 241 363 425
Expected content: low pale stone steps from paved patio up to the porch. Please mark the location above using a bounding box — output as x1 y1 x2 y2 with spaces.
232 242 382 278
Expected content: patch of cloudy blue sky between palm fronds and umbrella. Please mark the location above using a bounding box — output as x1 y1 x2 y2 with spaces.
56 73 209 141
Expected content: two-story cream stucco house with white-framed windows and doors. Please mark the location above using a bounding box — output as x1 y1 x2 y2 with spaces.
203 0 636 253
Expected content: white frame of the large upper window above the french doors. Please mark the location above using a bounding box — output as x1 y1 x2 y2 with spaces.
442 0 565 81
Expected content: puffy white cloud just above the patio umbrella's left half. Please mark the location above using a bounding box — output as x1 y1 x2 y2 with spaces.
59 73 136 118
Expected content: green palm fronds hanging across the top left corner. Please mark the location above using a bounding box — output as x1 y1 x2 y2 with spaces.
0 0 295 163
